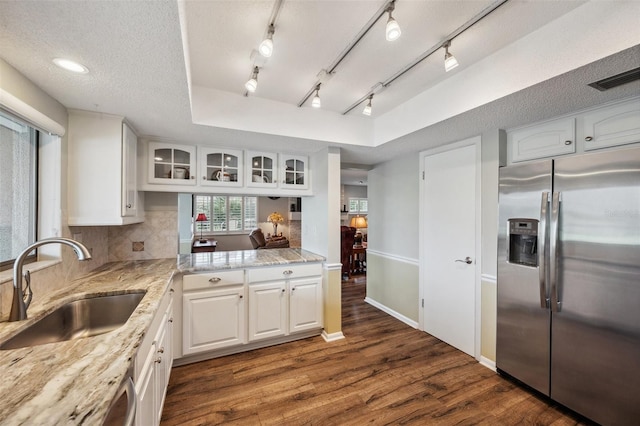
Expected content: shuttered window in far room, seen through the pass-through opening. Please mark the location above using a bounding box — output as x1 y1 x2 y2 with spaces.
193 195 258 234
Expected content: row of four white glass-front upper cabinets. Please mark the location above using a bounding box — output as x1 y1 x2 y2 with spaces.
138 141 311 197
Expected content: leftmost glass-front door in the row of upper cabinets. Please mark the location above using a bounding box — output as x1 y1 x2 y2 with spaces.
148 142 196 185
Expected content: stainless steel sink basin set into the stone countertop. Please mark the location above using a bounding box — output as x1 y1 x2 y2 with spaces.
0 292 145 350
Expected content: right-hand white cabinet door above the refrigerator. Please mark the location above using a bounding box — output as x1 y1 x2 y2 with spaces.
582 99 640 151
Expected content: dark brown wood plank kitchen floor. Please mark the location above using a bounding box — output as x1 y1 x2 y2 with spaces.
162 278 585 426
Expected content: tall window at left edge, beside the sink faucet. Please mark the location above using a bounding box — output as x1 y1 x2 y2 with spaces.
0 110 38 269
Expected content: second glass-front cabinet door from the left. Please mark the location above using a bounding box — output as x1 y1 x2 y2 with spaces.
200 148 243 187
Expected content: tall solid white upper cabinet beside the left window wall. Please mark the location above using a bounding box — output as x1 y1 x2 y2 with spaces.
67 110 144 226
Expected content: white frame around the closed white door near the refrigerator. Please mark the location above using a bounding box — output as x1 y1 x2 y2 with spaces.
418 136 482 361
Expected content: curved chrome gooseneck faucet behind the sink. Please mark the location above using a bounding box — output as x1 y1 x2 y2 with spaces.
9 238 91 321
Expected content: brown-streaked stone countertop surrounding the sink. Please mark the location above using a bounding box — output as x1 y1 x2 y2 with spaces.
0 259 176 425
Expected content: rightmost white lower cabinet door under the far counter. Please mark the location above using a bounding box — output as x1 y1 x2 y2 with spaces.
289 277 323 333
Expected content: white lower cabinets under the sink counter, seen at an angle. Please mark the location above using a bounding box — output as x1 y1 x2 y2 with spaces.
134 290 173 426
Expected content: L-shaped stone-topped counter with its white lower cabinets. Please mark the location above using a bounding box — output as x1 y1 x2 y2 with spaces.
0 249 324 425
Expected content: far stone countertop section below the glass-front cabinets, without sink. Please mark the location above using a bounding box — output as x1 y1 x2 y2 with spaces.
178 248 325 273
